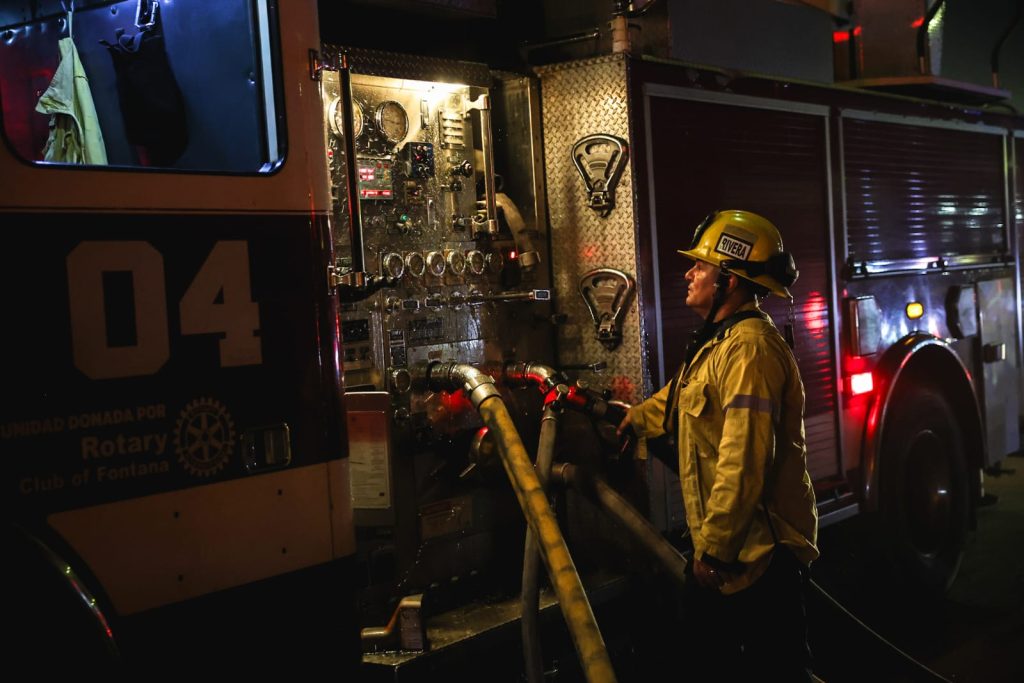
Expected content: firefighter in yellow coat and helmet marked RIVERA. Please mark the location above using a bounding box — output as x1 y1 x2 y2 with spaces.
618 210 818 681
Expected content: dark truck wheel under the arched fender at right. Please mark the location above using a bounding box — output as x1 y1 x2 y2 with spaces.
881 388 970 594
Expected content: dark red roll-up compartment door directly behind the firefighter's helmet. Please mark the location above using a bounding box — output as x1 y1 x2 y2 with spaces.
646 96 840 479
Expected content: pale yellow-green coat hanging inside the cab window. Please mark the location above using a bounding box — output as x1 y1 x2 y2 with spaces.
36 38 106 164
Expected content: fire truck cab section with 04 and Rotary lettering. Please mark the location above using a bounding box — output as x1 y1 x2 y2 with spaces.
0 0 357 671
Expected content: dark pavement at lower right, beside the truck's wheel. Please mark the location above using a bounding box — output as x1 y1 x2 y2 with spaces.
809 456 1024 683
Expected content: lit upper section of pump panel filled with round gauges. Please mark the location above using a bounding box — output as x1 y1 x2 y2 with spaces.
323 65 514 407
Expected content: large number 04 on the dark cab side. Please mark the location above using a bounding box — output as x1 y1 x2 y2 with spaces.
68 241 263 380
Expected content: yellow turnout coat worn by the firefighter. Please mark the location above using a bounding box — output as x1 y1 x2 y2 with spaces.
630 303 818 594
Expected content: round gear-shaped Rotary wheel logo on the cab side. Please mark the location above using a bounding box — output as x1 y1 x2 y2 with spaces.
174 398 234 477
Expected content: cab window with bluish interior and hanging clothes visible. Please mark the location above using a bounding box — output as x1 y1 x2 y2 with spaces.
0 0 285 174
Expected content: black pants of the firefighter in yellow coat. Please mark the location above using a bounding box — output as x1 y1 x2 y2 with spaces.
681 546 811 683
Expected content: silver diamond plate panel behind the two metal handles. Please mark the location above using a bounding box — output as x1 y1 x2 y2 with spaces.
538 55 647 403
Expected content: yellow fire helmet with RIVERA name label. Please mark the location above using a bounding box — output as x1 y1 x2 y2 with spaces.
679 209 800 299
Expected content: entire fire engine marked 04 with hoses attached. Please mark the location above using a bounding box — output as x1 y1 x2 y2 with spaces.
0 0 1024 680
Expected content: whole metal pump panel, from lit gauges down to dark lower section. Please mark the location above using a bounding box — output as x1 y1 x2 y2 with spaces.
322 48 551 625
